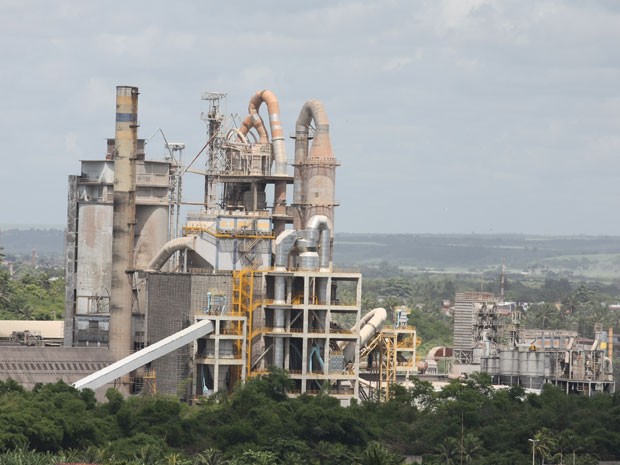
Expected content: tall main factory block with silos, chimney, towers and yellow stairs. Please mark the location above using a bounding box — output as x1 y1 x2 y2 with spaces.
60 86 386 403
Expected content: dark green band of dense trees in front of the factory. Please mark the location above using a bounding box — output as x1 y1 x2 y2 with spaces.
0 372 620 465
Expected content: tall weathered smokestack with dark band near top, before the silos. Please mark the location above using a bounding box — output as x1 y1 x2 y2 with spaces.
110 86 138 360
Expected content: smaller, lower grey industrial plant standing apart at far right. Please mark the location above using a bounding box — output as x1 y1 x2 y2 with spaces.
453 292 615 396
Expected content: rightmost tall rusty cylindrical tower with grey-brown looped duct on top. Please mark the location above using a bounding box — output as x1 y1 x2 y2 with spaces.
293 100 337 229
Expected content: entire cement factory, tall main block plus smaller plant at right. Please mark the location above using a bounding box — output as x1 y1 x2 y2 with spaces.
0 86 614 398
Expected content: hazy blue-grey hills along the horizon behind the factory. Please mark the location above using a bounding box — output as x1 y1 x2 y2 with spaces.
0 226 620 279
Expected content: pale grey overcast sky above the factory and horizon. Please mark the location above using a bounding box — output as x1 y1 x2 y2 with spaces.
0 0 620 235
